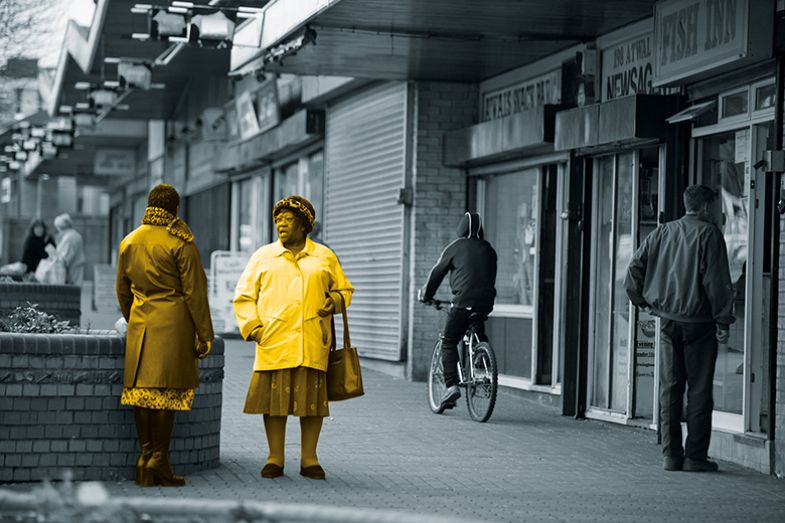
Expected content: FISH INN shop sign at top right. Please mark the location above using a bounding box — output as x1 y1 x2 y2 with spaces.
654 0 772 87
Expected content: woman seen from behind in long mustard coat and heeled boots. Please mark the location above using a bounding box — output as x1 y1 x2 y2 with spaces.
117 184 213 486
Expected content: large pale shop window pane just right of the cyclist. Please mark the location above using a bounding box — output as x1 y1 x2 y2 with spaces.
484 169 540 307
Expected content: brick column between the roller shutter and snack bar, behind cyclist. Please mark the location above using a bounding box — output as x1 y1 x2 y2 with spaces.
406 82 478 381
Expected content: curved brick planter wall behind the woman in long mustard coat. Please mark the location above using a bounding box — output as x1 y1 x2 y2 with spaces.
0 331 224 482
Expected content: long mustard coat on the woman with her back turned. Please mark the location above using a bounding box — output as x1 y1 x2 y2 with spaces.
117 219 213 389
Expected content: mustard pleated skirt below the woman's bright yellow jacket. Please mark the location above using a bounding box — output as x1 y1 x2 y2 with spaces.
243 367 330 417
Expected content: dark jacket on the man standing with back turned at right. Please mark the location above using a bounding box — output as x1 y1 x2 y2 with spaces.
624 215 734 325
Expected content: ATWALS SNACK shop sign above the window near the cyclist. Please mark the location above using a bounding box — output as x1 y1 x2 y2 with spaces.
481 68 562 122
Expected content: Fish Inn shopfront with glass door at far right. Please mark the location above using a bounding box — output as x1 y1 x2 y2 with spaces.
655 1 776 472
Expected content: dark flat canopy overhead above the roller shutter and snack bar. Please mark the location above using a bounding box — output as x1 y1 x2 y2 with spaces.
235 0 654 82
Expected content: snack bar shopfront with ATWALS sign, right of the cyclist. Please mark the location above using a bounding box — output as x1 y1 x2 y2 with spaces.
445 56 576 395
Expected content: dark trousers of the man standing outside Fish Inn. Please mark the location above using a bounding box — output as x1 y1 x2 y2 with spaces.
660 319 717 460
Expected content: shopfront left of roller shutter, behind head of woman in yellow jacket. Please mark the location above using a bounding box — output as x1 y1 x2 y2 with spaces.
218 77 324 253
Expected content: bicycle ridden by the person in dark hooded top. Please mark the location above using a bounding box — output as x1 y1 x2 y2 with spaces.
428 299 499 423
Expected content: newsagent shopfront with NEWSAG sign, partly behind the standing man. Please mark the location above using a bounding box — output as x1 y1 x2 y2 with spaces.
556 13 683 428
